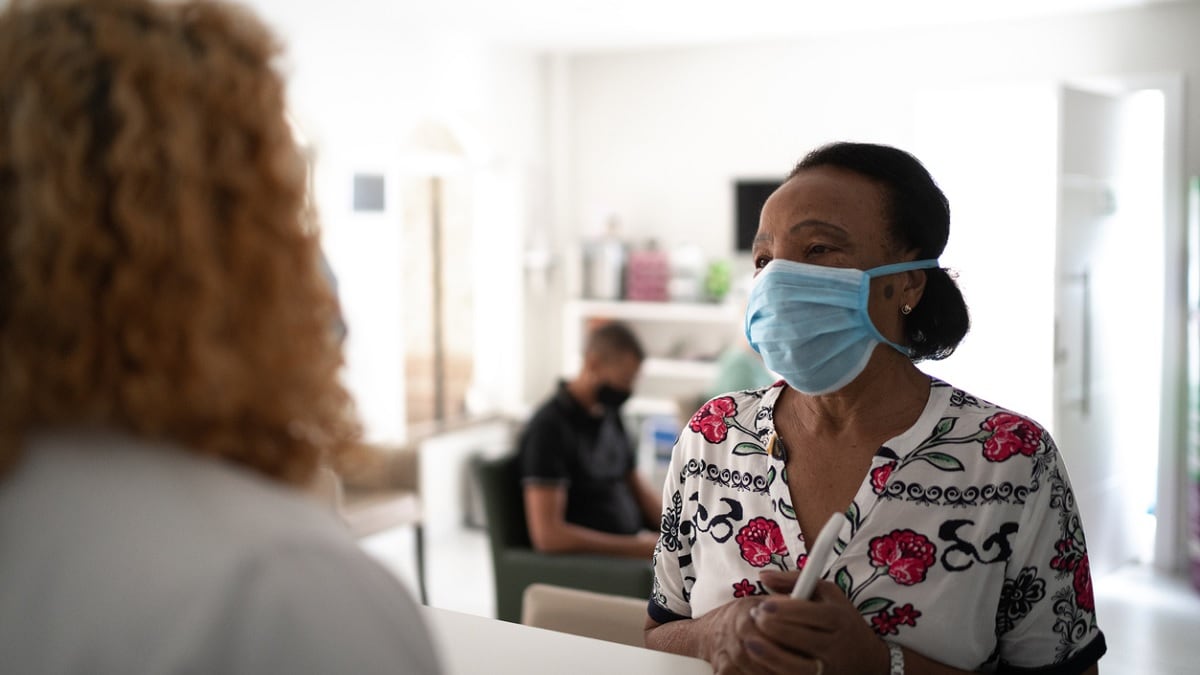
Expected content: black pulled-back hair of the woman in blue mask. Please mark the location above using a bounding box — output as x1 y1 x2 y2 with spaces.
787 143 971 362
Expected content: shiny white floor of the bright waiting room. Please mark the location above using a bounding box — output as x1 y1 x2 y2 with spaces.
364 528 1200 675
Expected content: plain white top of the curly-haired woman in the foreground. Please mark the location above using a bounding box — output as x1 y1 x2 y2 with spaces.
0 431 439 675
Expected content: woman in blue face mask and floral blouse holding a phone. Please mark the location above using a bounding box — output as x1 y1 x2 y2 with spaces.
646 143 1105 675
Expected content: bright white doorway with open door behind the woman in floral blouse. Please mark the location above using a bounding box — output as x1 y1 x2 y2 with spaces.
914 76 1187 573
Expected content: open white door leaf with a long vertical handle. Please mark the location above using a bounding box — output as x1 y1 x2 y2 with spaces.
1052 86 1166 573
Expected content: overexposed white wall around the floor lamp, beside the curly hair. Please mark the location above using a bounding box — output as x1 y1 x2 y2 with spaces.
258 0 546 442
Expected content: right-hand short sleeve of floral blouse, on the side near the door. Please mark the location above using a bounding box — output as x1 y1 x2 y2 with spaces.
996 435 1105 675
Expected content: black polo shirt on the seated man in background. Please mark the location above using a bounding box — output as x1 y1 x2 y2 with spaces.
520 382 644 534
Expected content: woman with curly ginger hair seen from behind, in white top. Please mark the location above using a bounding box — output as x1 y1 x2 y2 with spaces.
0 0 438 673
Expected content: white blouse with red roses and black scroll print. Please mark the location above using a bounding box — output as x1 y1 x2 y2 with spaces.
649 380 1105 673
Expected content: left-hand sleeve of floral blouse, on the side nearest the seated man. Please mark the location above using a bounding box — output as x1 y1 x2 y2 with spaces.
647 429 695 623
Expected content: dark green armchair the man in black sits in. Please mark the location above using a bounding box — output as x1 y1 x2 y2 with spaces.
472 455 654 623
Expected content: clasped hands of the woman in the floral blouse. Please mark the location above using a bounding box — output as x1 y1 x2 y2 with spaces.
704 572 888 675
